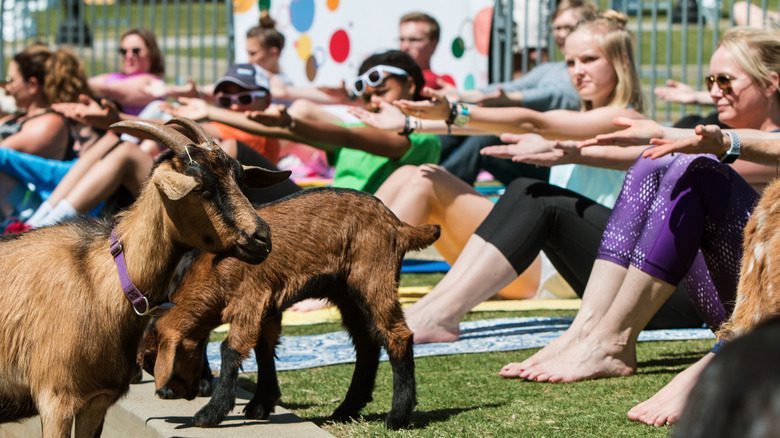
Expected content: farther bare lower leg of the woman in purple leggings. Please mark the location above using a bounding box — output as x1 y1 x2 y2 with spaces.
499 260 628 378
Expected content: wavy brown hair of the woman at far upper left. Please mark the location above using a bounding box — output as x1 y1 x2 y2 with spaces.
13 43 91 103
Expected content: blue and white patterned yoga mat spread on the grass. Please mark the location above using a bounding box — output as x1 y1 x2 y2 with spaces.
207 318 715 372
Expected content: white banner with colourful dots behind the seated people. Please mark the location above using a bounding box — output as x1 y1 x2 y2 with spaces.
233 0 493 90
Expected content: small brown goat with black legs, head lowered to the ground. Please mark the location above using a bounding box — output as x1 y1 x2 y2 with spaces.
139 189 440 429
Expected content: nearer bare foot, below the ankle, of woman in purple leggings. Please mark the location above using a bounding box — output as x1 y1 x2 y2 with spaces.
512 337 636 383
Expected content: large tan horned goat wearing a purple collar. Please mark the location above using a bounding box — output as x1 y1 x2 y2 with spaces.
0 119 289 437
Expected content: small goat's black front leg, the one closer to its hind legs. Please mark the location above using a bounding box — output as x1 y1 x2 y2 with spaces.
244 312 282 420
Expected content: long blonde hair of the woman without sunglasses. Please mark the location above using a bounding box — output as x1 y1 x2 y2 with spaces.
570 10 644 112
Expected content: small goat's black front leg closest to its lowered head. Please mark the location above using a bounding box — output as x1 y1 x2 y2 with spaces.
192 340 241 427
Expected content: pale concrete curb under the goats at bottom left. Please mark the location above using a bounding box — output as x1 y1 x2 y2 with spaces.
0 375 333 438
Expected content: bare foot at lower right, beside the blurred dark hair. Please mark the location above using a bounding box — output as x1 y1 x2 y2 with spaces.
628 353 715 426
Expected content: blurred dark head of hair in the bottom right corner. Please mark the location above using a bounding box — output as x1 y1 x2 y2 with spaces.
672 317 780 438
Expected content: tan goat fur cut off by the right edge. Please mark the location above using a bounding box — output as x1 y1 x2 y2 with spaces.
718 179 780 340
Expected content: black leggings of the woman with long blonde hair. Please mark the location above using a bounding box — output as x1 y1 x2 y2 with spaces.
476 178 703 328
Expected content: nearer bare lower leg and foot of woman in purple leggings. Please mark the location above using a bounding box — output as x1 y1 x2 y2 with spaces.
521 267 675 382
